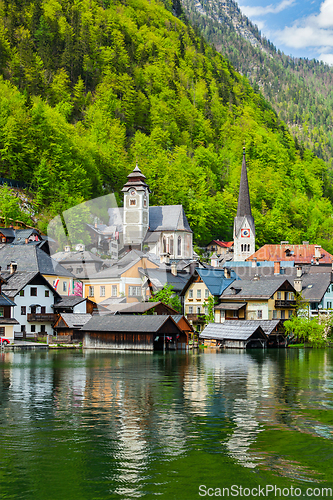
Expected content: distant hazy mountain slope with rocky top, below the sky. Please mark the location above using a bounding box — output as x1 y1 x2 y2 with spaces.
181 0 333 166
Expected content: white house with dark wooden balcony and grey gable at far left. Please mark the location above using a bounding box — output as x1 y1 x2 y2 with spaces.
3 271 60 338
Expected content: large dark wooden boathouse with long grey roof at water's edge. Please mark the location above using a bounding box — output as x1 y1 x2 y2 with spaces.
82 314 187 351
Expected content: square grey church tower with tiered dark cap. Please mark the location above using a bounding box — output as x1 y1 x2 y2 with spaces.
122 165 150 250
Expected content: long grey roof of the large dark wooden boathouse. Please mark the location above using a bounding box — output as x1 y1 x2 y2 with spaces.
83 314 175 333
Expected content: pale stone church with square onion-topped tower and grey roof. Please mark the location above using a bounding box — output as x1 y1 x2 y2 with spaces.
108 166 193 263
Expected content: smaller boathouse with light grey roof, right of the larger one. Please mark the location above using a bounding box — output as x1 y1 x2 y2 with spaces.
199 320 268 349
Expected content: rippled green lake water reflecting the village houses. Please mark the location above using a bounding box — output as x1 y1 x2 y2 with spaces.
0 349 333 500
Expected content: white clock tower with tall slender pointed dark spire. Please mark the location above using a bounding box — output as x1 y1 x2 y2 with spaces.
234 148 256 262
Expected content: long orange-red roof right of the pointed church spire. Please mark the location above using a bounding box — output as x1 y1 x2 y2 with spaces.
246 244 333 264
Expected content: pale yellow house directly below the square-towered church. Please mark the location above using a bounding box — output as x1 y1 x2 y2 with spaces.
82 251 159 304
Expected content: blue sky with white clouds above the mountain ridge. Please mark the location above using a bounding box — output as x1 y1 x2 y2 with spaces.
238 0 333 65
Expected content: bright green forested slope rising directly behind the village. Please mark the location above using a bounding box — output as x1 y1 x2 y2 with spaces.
0 0 333 250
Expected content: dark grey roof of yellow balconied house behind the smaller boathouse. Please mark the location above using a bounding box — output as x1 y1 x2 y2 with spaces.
220 278 295 301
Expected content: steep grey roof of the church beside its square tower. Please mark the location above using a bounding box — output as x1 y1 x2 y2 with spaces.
148 205 192 234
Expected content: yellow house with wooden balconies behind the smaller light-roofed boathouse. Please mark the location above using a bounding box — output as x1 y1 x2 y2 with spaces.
215 278 296 323
